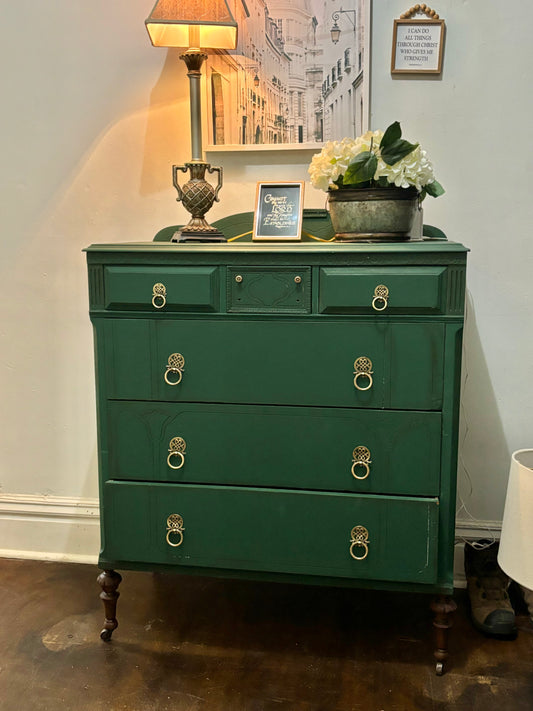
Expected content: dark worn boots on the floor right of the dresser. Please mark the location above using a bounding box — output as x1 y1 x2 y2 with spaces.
465 541 533 637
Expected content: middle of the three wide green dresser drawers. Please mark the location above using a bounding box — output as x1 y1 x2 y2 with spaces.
104 401 441 496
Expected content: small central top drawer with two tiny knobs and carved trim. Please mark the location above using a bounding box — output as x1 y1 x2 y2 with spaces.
228 266 311 314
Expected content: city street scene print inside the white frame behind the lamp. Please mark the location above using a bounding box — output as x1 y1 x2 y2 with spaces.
207 0 366 145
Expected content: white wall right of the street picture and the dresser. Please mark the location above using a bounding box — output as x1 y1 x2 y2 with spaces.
371 0 533 536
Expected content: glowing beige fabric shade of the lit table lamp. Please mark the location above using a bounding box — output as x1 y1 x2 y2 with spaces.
145 0 237 49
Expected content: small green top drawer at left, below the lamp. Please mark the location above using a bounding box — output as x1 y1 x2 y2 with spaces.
104 266 220 312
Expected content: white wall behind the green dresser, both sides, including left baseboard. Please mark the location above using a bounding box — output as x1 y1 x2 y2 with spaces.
0 0 533 560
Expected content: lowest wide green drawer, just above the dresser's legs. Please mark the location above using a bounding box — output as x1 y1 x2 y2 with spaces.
101 481 438 583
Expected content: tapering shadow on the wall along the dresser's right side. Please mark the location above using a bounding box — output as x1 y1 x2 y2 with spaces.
457 292 511 526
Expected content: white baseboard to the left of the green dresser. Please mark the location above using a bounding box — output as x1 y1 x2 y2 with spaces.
0 494 100 564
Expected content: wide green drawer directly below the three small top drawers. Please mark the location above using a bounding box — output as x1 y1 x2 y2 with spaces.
101 318 444 410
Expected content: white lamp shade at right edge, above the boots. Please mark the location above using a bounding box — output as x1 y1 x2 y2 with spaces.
498 449 533 590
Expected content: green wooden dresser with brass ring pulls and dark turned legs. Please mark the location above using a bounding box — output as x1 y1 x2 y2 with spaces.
87 240 467 673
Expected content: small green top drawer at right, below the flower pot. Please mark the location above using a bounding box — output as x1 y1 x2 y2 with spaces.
319 267 446 314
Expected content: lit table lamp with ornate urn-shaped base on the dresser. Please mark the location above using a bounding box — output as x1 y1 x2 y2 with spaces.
145 0 237 242
